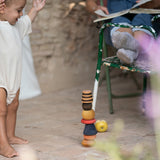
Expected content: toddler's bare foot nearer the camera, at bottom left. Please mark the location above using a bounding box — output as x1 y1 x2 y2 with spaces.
0 145 18 158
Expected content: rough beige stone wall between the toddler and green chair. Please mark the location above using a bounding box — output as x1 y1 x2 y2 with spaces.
26 0 98 92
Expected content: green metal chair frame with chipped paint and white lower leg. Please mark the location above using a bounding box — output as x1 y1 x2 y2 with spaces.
92 10 156 114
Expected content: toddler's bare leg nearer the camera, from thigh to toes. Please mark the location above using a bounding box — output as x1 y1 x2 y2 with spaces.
0 88 18 158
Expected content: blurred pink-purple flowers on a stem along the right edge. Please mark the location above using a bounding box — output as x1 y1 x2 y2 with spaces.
140 37 160 159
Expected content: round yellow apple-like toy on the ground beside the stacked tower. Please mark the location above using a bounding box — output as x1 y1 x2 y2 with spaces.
95 120 108 132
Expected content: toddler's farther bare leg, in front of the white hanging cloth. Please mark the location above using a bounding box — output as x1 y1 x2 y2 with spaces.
6 91 28 144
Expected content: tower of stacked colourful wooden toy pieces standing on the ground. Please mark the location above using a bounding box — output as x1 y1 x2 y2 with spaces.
81 90 97 147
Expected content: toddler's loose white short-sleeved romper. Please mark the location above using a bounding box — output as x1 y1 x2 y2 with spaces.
0 15 32 104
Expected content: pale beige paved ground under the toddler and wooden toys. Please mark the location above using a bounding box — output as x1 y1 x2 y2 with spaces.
0 71 156 160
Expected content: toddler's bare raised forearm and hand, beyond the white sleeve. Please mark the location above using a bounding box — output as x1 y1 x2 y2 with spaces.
28 0 46 22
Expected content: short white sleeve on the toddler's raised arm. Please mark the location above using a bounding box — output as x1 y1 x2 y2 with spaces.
16 15 32 39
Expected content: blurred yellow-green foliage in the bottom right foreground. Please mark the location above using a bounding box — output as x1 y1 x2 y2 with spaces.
95 120 153 160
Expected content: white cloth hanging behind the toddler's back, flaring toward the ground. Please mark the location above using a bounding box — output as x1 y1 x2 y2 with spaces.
19 36 41 100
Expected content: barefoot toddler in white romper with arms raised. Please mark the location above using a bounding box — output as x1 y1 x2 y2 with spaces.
0 0 46 158
